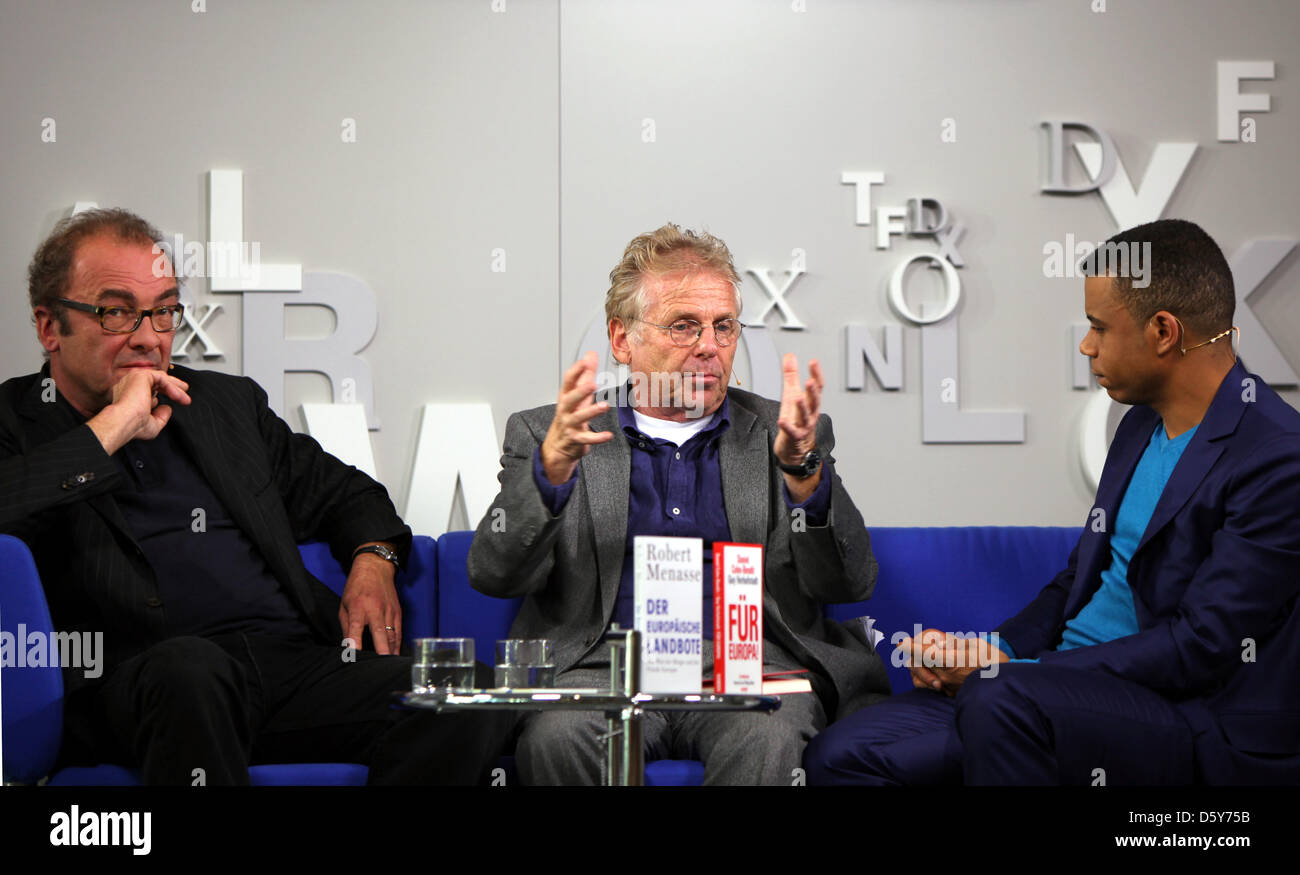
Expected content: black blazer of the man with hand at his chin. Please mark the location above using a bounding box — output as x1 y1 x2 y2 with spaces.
0 365 411 690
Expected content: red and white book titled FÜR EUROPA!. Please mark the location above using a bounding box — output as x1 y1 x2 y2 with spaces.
714 542 763 693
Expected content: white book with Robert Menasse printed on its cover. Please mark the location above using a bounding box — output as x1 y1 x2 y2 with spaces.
632 534 705 693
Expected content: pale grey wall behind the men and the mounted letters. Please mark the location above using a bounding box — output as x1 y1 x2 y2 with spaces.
0 0 1300 528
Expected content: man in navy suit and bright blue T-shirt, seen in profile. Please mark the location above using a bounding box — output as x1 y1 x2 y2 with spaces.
805 220 1300 785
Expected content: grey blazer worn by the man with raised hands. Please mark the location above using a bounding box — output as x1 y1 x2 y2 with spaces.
469 389 889 719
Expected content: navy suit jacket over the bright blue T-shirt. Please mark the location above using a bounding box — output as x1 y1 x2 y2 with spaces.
998 361 1300 784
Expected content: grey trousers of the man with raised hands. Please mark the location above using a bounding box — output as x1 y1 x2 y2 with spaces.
515 641 826 787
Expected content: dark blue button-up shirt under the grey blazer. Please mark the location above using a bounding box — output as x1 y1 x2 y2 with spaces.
533 393 831 638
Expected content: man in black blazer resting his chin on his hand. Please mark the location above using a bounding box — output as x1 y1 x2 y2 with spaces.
0 209 514 785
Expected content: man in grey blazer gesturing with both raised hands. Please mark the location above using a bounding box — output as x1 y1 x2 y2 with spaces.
469 225 888 785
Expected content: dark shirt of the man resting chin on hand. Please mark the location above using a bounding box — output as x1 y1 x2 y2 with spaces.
113 428 311 637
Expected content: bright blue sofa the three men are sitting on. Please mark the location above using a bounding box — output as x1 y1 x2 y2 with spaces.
0 527 1079 785
